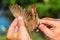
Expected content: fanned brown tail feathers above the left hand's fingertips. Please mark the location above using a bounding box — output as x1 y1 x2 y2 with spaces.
9 4 25 17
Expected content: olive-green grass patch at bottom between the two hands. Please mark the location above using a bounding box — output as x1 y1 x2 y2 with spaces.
30 32 49 40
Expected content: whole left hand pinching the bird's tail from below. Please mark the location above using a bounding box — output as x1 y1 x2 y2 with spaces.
7 17 30 40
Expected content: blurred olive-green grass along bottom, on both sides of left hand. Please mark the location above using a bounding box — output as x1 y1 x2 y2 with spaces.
0 32 48 40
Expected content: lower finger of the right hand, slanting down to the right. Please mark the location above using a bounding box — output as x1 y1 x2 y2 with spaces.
39 24 54 38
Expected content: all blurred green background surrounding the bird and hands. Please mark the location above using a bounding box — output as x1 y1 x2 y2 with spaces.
0 0 60 40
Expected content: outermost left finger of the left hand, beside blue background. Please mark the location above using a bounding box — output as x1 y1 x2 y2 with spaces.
7 19 17 38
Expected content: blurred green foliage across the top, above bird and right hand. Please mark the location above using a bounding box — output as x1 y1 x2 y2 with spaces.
0 0 60 18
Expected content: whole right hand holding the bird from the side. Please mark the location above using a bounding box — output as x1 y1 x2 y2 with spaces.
39 18 60 40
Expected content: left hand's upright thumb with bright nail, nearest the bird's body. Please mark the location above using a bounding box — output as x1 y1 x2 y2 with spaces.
18 17 30 40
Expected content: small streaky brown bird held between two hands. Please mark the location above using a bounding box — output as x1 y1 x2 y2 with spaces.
9 4 39 32
